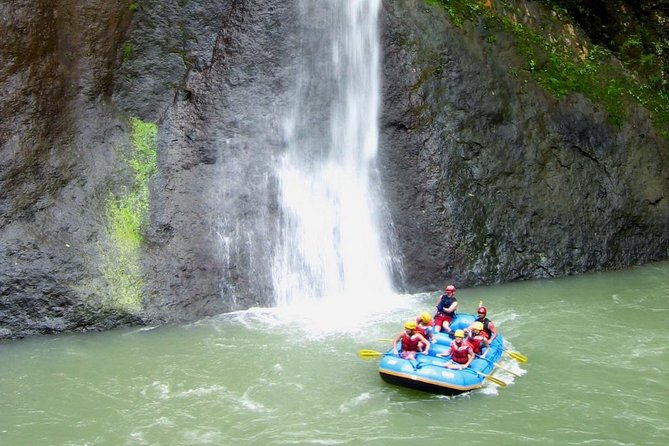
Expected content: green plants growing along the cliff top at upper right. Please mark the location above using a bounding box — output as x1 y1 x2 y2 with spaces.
426 0 669 139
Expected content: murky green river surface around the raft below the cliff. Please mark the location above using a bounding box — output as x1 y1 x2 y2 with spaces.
0 262 669 446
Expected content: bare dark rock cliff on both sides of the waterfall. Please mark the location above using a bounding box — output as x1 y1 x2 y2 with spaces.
0 0 669 337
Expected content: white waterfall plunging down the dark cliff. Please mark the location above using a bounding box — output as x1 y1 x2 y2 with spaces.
272 0 392 306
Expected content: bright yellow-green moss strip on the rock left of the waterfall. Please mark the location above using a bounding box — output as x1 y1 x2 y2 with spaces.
102 118 158 311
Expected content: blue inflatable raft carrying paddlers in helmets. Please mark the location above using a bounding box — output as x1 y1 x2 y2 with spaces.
379 313 504 395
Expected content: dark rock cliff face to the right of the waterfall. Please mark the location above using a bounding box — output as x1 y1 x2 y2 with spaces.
381 1 669 287
